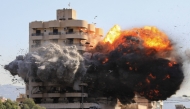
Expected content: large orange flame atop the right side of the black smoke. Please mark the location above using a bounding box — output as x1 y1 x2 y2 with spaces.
123 26 171 51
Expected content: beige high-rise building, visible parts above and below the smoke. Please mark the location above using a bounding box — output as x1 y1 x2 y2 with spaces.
26 9 103 109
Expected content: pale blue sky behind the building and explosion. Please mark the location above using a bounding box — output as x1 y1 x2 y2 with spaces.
0 0 190 95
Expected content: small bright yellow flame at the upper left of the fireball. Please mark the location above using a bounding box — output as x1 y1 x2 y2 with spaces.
103 25 121 44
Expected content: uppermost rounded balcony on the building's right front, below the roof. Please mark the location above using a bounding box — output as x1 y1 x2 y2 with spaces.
65 32 88 40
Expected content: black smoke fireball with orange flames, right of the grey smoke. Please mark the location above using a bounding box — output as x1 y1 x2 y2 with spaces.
84 25 184 104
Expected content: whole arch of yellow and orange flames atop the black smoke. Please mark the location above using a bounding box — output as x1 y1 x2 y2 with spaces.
103 25 172 51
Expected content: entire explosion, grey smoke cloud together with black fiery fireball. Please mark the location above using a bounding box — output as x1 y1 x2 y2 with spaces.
5 25 184 104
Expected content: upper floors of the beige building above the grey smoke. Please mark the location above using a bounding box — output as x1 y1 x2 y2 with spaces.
29 9 103 52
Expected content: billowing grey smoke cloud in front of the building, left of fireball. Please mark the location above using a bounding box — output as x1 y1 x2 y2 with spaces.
5 43 86 89
